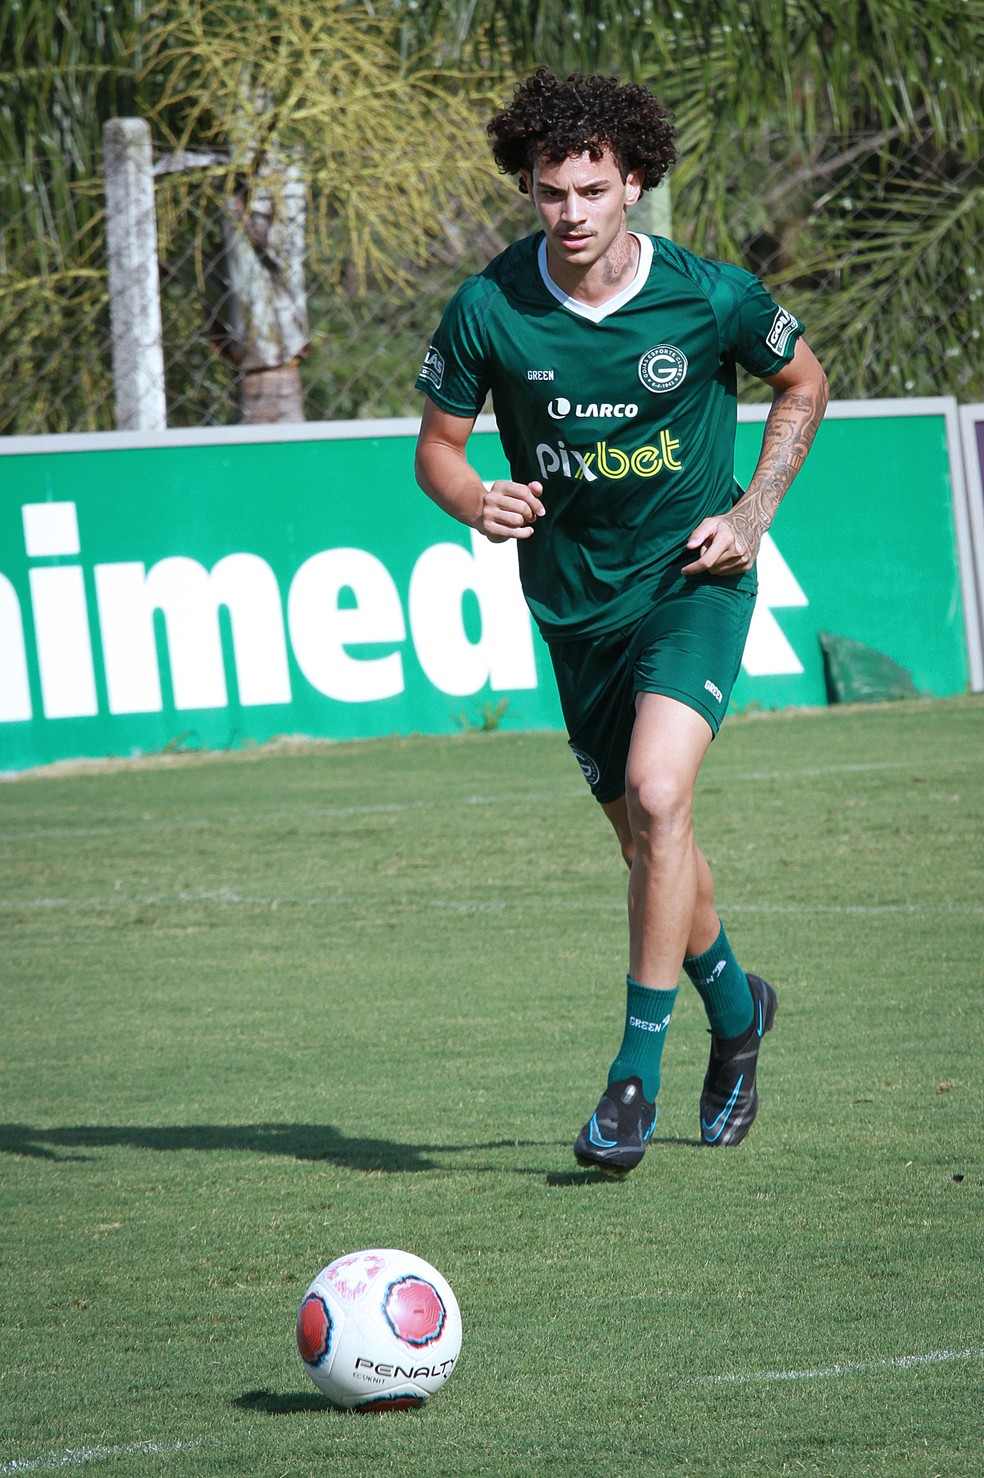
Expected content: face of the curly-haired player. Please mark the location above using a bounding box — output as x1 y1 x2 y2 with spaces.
525 148 641 270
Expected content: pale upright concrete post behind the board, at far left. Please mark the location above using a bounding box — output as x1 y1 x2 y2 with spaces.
102 118 167 432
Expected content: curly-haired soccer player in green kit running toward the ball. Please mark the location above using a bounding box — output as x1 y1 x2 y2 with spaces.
417 68 827 1174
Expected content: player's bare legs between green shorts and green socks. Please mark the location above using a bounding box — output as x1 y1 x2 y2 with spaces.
593 693 720 990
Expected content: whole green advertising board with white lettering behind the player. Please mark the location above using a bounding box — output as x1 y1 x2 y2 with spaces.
0 402 969 772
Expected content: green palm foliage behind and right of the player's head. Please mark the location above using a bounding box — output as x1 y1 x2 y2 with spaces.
399 0 984 399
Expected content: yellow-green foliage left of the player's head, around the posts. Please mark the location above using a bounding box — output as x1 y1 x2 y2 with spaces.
0 0 493 432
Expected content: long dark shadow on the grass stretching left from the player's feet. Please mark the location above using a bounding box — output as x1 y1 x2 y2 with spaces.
0 1123 564 1174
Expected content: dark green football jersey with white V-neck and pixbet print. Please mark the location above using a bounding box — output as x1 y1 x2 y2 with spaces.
417 232 802 638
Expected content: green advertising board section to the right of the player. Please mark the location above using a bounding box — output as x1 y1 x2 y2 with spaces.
731 401 963 708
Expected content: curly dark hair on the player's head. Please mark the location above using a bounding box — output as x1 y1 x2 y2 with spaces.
486 67 677 191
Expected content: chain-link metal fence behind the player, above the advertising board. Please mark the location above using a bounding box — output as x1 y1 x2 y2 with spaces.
0 136 984 435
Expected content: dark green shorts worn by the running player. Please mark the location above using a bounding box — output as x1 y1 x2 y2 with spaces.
550 581 755 804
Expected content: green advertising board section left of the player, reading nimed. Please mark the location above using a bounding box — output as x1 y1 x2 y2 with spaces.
0 413 560 769
